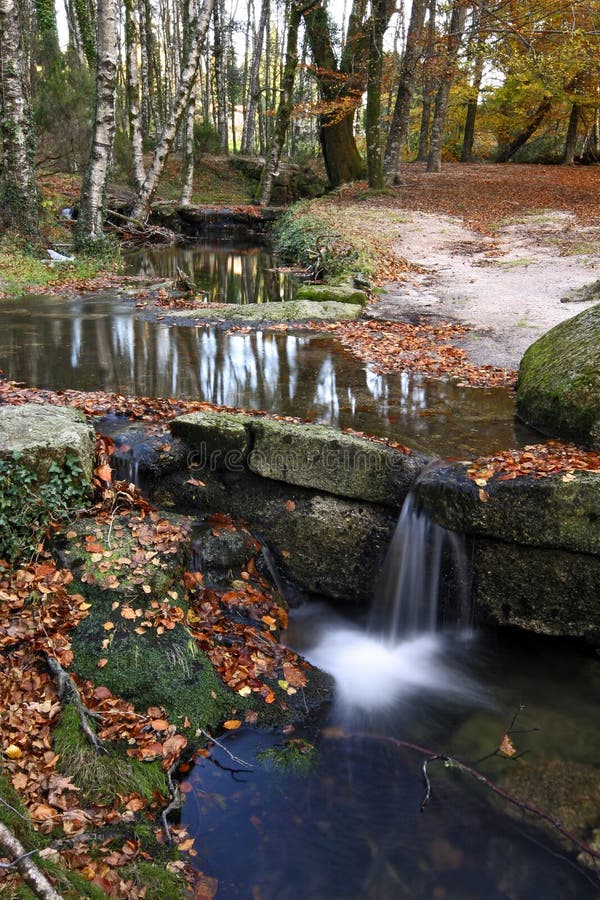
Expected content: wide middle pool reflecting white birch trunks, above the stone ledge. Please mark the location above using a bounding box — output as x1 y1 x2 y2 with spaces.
0 294 533 456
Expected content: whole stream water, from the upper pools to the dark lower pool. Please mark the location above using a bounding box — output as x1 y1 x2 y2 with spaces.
0 241 600 900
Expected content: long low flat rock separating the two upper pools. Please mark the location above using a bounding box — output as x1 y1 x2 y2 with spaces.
166 300 362 323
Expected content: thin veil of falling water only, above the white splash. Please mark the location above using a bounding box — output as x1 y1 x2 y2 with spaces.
369 493 472 643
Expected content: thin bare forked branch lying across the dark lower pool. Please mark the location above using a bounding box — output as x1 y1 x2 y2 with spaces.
341 732 600 860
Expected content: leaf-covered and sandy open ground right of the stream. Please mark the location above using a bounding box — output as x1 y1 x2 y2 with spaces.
317 163 600 369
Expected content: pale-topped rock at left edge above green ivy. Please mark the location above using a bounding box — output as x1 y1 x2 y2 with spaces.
0 403 96 482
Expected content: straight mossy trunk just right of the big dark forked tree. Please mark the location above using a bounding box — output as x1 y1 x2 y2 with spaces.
365 0 387 190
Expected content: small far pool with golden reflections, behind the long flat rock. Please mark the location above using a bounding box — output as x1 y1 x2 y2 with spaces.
127 238 295 303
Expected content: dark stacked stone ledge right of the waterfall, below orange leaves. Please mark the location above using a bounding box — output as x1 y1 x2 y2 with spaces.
416 464 600 641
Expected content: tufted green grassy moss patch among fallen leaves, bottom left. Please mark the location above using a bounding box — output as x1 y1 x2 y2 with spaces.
53 704 169 804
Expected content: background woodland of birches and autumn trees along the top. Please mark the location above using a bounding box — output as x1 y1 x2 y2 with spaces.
0 0 600 245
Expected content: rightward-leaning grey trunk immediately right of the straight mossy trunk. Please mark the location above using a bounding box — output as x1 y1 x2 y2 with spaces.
383 0 428 184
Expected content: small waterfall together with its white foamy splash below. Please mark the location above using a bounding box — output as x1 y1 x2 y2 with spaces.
298 494 482 718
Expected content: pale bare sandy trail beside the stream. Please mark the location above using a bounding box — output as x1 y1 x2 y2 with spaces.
369 212 600 369
